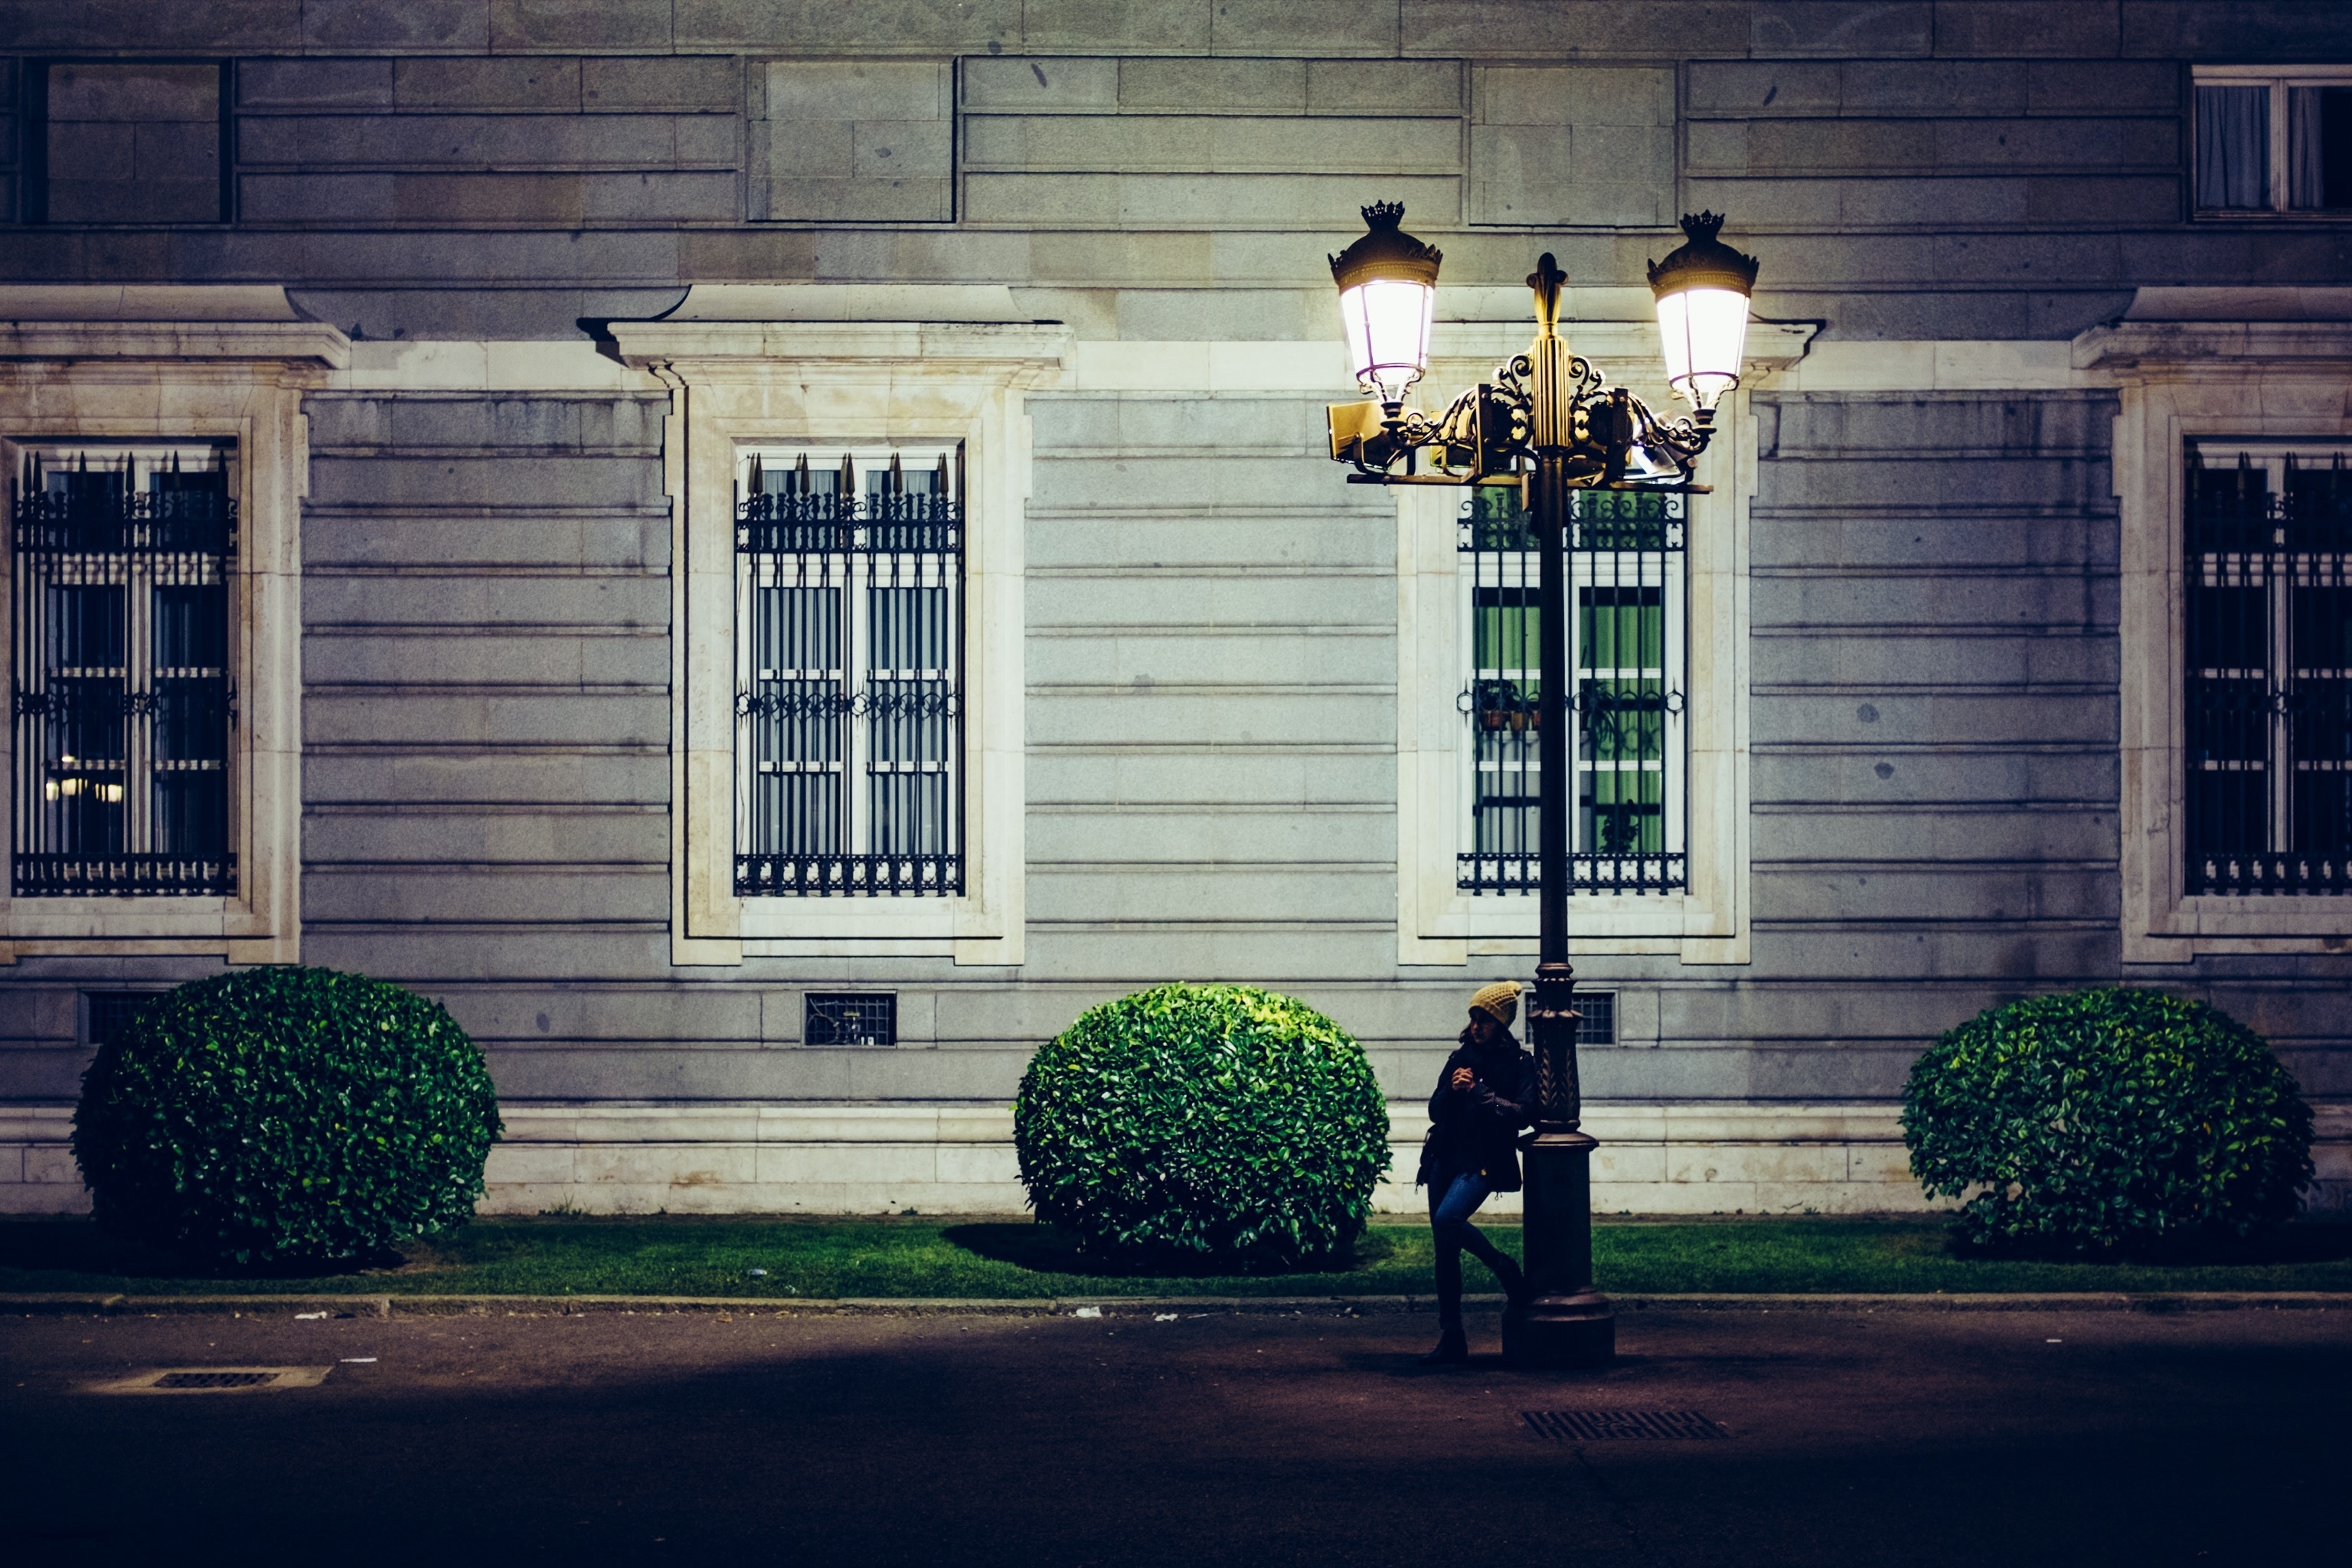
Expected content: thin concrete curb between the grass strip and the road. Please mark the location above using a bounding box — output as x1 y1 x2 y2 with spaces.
0 1291 2352 1319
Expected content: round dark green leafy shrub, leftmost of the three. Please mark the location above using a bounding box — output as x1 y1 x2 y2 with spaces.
73 969 505 1265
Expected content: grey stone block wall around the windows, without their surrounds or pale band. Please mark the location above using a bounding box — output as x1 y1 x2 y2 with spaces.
0 0 2352 1128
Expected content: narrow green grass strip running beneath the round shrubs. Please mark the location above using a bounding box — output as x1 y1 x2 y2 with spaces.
14 1215 2352 1300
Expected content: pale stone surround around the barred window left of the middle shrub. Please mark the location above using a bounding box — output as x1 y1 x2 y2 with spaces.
609 285 1075 966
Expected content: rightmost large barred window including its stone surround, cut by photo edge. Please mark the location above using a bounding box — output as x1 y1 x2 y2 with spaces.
2075 305 2352 964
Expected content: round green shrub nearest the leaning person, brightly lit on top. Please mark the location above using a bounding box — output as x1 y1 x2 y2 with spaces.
1014 985 1387 1267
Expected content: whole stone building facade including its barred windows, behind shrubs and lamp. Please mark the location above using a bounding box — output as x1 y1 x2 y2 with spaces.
0 0 2352 1213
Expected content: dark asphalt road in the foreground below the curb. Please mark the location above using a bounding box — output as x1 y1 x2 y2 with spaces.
0 1312 2352 1568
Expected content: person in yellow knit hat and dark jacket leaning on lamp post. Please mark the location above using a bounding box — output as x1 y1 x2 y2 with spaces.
1418 980 1536 1364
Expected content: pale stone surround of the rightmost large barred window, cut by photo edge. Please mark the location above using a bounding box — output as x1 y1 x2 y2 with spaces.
2075 305 2352 964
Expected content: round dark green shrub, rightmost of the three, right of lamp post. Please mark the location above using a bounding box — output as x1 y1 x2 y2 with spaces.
1903 990 2312 1256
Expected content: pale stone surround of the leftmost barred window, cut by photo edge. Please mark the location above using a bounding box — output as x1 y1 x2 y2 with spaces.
0 285 351 964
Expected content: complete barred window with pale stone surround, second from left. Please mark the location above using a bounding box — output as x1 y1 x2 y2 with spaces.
612 303 1075 964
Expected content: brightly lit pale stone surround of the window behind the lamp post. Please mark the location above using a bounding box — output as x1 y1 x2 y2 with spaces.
1395 322 1814 964
